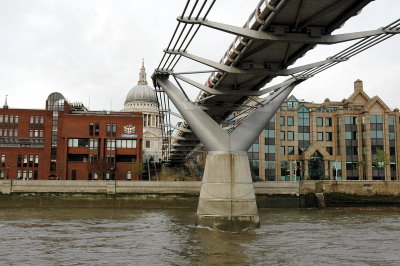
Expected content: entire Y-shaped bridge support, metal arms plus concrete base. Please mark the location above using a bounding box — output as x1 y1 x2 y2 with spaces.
153 74 302 230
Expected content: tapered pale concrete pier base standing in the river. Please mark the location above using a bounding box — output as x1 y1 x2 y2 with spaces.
196 152 260 231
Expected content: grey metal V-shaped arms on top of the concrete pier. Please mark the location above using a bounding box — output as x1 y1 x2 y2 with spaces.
152 73 303 152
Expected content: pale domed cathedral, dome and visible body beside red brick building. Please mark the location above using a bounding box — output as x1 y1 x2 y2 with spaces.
122 61 162 161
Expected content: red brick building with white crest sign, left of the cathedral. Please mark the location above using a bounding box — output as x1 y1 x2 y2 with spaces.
0 93 143 180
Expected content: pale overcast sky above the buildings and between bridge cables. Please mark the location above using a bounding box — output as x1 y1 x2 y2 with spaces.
0 0 400 110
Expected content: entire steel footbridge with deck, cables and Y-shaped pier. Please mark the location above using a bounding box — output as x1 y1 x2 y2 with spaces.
152 0 400 229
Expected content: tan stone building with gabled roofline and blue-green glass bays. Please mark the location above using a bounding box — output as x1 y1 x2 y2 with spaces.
249 80 400 181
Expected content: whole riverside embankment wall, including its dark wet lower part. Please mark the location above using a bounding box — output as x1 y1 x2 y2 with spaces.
0 180 400 207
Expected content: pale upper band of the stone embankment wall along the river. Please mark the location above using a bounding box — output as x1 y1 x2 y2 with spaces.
0 180 400 196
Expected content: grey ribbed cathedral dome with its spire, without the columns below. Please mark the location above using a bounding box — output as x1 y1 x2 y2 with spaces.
125 62 157 104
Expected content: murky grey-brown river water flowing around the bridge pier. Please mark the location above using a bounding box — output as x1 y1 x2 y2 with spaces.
0 203 400 265
